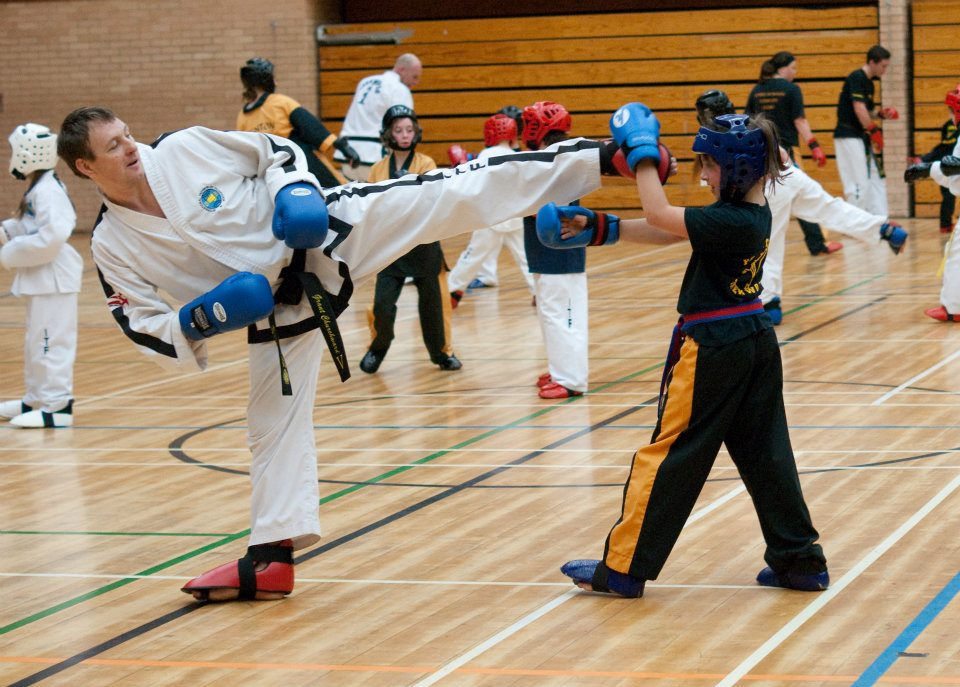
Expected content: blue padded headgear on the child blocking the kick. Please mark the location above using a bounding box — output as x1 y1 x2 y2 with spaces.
693 114 767 200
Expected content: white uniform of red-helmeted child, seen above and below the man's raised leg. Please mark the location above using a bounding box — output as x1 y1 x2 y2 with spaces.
447 141 533 293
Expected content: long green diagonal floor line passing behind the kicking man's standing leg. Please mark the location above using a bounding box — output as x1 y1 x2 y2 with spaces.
0 274 883 635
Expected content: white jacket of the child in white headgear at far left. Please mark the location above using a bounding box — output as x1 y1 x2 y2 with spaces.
0 170 83 296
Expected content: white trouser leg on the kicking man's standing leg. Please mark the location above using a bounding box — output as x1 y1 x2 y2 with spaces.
247 304 326 549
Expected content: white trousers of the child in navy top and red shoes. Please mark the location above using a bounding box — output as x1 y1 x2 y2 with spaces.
536 272 590 392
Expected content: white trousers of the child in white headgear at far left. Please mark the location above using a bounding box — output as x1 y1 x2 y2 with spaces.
22 293 77 413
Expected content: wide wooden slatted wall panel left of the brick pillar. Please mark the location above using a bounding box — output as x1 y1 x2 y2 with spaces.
319 4 878 216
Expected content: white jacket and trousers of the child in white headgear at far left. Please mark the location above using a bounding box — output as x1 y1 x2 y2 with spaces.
0 170 83 413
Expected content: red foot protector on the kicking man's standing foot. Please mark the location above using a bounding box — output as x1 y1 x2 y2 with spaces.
181 539 293 600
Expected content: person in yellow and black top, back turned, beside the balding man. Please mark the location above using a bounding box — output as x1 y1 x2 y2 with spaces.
237 57 360 188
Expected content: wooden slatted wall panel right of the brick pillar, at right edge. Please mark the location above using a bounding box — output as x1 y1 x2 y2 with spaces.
912 0 960 223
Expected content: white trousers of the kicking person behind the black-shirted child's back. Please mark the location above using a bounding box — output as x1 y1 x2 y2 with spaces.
760 167 887 303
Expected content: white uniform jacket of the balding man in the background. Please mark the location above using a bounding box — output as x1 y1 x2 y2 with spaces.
333 69 413 165
